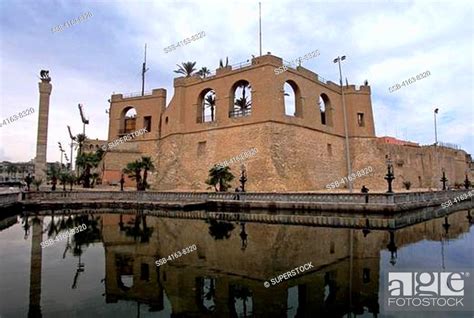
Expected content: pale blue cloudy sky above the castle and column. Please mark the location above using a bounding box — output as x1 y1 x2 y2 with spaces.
0 0 474 162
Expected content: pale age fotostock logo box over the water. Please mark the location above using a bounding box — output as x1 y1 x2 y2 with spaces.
385 271 474 311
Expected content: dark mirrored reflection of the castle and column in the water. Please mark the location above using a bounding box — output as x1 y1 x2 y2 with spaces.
24 211 472 317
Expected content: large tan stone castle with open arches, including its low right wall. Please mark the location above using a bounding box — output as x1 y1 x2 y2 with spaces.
98 53 473 192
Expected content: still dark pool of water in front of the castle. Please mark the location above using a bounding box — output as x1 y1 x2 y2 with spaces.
0 210 474 318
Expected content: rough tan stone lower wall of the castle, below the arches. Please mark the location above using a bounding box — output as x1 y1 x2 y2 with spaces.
152 123 345 191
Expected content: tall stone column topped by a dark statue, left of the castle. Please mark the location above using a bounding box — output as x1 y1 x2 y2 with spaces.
35 71 53 183
